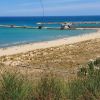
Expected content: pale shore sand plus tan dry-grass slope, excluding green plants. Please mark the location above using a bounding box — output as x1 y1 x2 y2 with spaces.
0 30 100 78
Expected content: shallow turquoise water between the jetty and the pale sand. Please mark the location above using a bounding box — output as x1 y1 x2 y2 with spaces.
0 28 96 47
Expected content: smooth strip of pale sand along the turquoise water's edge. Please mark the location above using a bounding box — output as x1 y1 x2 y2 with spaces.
0 30 100 56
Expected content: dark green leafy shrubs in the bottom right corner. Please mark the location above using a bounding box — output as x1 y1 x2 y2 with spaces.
69 59 100 100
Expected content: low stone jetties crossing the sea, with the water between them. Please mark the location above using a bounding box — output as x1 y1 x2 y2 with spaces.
0 22 100 30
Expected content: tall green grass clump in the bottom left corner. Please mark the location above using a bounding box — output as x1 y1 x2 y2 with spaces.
0 72 32 100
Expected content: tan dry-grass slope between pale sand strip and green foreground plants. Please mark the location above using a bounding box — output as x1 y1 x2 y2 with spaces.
0 39 100 78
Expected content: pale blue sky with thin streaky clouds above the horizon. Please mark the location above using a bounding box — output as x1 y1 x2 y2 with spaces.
0 0 100 16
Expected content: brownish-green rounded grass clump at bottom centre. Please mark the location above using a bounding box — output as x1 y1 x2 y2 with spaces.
36 73 65 100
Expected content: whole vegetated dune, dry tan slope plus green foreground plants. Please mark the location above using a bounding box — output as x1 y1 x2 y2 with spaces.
0 39 100 100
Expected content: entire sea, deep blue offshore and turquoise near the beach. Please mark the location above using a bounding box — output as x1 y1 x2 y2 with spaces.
0 16 100 48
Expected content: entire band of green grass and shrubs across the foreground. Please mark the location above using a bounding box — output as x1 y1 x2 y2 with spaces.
0 58 100 100
